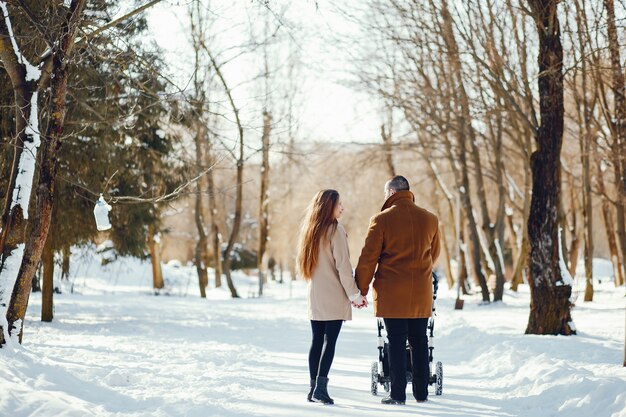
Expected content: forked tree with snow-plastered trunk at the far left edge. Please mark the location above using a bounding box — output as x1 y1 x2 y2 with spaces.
0 0 86 346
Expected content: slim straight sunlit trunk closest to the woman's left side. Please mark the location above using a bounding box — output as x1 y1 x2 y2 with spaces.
257 111 272 297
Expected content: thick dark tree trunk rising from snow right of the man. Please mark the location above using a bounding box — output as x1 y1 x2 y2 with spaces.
526 0 576 335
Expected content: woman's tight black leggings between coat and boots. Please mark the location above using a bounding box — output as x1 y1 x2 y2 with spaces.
309 320 343 379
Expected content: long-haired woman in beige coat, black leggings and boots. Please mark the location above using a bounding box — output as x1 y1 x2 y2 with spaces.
298 190 367 404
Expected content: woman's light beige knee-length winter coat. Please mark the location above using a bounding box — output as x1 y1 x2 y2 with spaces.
308 224 359 321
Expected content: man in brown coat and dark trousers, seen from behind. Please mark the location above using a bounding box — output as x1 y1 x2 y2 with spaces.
356 175 439 404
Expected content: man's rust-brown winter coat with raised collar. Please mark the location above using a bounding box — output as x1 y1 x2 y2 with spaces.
356 191 439 318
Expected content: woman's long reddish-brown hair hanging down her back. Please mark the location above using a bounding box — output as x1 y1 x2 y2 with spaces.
298 190 339 280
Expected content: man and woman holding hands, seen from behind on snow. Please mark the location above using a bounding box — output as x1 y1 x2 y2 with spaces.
298 176 439 404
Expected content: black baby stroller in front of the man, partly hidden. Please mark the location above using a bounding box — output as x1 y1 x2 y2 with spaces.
371 272 443 395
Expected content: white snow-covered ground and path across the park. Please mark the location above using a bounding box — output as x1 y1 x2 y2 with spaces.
0 249 626 417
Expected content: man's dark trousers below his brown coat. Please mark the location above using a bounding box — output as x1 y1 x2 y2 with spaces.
385 318 430 401
